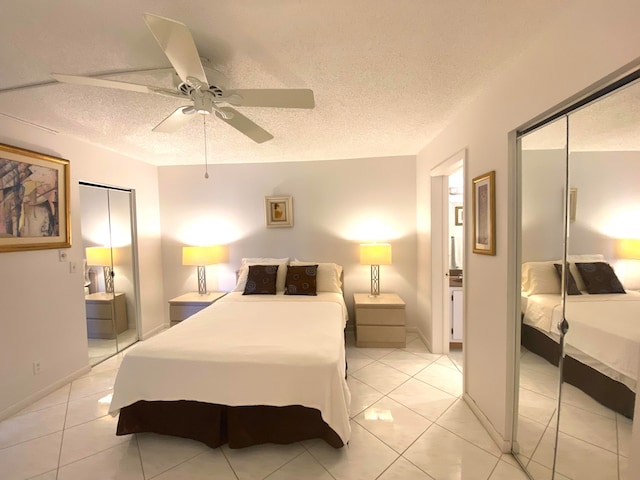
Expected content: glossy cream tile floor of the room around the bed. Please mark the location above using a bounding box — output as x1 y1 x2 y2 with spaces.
0 334 527 480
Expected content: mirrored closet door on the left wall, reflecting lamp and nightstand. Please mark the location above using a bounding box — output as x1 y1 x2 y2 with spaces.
80 183 139 365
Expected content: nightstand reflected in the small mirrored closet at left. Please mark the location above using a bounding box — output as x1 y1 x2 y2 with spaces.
84 292 127 338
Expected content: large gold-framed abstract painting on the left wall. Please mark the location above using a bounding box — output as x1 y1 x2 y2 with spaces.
0 144 71 252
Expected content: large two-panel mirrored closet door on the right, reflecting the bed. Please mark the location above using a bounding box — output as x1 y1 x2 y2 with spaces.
513 75 640 480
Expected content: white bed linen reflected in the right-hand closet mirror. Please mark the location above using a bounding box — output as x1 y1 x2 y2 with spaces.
524 291 640 392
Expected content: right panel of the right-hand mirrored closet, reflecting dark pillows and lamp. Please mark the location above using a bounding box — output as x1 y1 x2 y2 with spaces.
556 77 640 480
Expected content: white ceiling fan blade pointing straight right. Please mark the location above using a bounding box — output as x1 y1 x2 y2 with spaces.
225 88 315 108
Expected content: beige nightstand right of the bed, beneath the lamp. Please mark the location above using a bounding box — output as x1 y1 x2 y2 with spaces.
353 293 407 347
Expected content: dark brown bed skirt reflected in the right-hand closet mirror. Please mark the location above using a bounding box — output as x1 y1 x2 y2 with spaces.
521 323 636 418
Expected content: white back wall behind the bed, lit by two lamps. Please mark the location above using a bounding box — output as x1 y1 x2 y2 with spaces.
159 157 417 326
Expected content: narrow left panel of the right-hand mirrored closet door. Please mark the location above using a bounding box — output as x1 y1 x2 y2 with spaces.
514 117 568 479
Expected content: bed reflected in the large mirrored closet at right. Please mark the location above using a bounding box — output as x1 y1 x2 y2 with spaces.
521 256 640 418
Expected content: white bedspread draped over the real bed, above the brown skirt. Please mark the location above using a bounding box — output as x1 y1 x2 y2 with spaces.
109 292 351 444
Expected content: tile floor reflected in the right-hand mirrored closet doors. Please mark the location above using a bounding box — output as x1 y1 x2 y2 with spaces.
517 347 638 480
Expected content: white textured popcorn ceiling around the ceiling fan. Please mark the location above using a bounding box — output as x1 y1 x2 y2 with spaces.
0 0 571 165
